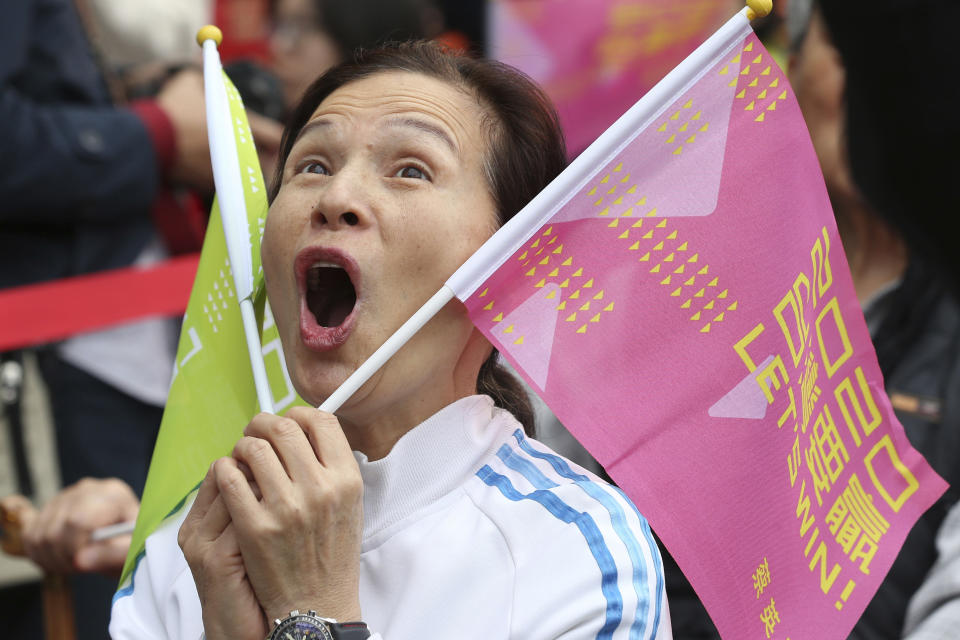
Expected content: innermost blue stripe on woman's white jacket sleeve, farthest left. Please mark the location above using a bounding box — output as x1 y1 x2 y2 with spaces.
476 465 623 640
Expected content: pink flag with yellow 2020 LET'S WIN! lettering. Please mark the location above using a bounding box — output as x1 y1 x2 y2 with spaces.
462 16 945 640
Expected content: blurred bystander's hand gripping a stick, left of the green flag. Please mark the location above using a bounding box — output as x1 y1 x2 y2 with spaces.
4 478 140 575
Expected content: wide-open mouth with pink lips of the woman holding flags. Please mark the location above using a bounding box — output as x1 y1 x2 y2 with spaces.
295 247 358 351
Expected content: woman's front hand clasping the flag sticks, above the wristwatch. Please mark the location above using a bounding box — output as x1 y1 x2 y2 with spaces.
217 407 363 620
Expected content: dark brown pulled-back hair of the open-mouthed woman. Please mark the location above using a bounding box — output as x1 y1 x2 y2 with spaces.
270 41 567 434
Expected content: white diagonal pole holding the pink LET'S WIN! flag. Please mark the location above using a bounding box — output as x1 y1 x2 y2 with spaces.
319 0 773 413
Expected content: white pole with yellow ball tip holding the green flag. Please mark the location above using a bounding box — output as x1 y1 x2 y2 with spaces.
197 25 273 413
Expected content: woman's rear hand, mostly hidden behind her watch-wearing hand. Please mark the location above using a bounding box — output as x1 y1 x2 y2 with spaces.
177 458 267 640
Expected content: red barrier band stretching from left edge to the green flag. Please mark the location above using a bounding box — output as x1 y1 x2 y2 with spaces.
0 253 200 351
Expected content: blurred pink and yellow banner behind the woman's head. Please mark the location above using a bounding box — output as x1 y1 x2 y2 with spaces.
488 0 743 155
